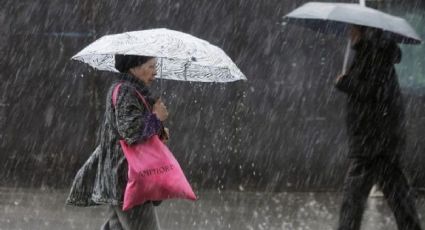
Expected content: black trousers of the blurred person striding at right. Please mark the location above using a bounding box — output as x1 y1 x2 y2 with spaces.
338 156 421 230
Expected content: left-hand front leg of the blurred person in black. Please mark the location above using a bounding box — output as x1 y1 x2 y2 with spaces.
338 158 374 230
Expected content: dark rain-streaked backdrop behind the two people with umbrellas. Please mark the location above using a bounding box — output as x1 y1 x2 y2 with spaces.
0 0 425 191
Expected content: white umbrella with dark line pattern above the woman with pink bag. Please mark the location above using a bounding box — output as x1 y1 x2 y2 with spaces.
72 28 246 82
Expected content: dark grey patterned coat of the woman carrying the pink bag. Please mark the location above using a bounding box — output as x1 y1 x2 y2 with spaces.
67 75 162 206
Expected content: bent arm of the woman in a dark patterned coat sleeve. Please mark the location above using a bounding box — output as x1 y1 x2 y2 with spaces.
115 85 161 145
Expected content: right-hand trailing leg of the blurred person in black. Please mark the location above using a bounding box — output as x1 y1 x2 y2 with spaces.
380 160 421 230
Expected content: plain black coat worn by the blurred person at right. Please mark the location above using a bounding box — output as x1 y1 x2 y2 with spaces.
336 40 405 157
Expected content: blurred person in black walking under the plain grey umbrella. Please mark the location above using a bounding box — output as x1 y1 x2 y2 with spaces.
336 26 421 230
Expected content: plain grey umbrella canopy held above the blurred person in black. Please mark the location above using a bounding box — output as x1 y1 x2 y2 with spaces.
284 2 421 44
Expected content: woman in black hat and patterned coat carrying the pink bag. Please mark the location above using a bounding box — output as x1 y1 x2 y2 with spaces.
67 55 168 230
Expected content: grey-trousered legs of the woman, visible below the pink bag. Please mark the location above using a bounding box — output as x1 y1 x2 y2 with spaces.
114 202 160 230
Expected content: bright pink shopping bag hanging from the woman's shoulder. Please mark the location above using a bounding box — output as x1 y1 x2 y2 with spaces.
112 83 196 211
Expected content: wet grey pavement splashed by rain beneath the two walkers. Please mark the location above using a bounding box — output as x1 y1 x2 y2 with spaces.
0 188 425 230
